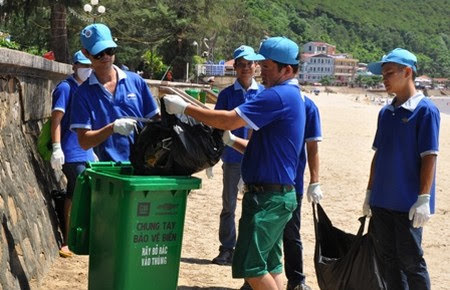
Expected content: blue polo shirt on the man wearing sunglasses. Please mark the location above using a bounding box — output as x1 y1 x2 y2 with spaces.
70 66 159 161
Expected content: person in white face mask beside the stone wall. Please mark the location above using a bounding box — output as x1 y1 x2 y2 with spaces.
50 51 94 257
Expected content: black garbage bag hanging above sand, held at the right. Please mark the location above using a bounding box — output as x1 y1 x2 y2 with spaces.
313 204 386 290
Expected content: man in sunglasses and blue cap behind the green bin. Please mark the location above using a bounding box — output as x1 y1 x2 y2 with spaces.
70 23 159 161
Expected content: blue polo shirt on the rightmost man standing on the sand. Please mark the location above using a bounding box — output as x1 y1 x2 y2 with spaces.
370 93 440 213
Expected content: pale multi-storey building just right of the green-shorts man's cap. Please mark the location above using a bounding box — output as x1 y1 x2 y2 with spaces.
299 53 334 83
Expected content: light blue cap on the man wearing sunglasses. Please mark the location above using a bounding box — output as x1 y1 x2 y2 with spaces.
80 23 117 55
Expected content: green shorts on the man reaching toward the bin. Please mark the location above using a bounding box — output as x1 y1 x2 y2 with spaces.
232 191 297 278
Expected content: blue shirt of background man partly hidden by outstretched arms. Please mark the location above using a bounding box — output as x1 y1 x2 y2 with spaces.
214 79 264 163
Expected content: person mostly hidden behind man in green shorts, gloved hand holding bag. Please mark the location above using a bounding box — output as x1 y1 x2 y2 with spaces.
283 96 323 290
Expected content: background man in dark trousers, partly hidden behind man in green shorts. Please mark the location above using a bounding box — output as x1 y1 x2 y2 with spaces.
212 45 264 265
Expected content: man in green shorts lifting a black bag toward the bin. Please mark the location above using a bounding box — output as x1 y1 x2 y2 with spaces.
164 37 305 290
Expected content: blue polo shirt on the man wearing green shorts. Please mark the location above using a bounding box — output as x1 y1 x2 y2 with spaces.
235 79 305 185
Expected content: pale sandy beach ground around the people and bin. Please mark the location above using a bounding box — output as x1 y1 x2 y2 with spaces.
31 93 450 290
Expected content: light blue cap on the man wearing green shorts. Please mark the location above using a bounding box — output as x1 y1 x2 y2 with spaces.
247 36 298 65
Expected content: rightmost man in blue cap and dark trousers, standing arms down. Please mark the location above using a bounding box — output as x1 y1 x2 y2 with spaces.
363 48 440 289
